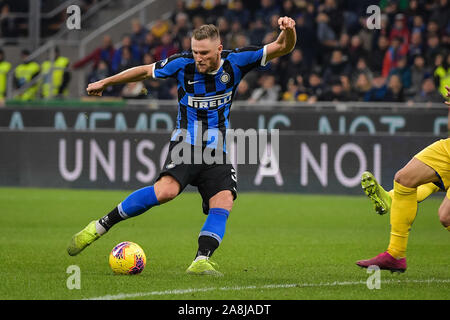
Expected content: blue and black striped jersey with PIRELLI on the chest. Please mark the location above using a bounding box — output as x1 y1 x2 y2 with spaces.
153 46 266 151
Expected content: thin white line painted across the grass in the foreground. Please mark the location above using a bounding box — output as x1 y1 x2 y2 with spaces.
86 279 450 300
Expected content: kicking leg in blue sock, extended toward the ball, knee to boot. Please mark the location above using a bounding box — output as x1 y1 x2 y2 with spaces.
67 176 180 256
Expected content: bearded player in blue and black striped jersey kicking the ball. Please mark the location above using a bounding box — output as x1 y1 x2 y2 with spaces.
67 17 297 276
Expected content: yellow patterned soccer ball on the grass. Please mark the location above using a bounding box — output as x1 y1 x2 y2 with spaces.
109 241 147 274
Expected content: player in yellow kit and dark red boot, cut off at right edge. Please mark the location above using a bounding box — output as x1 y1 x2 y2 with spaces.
356 86 450 272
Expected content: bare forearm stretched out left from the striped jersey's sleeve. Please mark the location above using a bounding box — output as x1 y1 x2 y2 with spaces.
86 64 154 96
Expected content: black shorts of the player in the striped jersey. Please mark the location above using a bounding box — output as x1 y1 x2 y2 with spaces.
156 141 237 214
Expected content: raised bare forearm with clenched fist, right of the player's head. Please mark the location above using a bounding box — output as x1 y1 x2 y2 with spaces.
266 17 297 61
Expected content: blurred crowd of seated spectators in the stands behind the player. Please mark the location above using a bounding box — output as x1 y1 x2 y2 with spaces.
0 0 450 103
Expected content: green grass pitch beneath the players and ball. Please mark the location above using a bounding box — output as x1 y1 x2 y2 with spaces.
0 188 450 300
